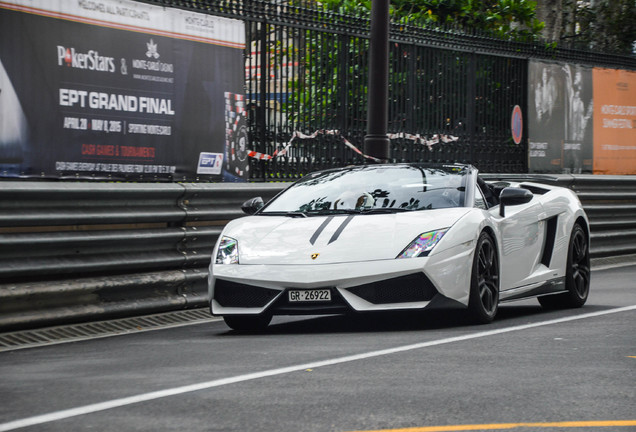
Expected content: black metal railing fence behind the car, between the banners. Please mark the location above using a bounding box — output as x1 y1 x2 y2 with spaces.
142 0 636 181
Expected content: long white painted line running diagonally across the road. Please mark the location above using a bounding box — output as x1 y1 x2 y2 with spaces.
0 305 636 432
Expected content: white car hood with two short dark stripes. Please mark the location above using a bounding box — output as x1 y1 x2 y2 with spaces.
223 208 470 265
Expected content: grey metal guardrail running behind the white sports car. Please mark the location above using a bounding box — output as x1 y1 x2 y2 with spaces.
0 174 636 331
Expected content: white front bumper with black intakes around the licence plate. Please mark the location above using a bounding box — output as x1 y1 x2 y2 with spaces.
209 251 470 315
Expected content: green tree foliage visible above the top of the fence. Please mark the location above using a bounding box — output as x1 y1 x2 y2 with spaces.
316 0 636 55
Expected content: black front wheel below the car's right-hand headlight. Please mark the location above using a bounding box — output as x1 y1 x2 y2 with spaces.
468 232 499 324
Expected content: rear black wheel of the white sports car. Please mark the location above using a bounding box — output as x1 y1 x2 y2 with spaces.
539 223 590 309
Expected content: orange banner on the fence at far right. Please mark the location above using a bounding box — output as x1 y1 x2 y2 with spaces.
593 68 636 174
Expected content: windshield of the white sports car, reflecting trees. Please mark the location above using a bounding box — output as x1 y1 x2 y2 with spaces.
260 164 467 216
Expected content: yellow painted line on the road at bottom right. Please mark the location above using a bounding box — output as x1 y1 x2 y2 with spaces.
346 420 636 432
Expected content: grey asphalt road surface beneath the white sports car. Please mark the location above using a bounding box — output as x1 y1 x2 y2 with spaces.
0 266 636 432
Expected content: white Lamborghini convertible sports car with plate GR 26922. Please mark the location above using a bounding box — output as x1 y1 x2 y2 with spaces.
208 164 590 331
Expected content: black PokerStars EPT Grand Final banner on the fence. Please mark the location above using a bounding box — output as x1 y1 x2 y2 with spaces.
0 0 246 181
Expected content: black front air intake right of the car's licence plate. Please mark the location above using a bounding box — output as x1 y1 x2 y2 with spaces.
348 273 437 304
